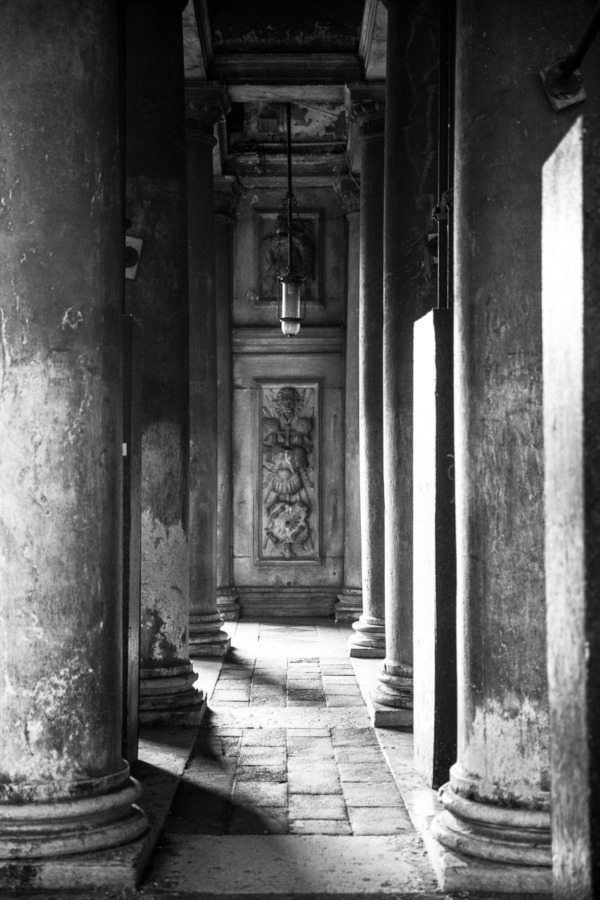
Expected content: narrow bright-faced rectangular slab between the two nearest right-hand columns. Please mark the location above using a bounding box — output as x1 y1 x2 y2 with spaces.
413 309 456 788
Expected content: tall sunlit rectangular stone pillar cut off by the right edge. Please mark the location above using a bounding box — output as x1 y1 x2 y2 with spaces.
542 114 600 900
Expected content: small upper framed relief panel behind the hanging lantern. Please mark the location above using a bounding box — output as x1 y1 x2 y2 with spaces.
256 209 322 303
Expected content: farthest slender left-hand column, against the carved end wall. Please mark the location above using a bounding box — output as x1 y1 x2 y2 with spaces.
215 186 240 621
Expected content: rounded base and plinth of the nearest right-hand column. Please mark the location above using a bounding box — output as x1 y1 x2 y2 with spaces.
429 784 552 893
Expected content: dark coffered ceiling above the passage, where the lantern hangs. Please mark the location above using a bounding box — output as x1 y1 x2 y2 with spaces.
183 0 386 175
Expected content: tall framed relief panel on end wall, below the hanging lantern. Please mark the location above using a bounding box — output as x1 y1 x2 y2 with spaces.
255 379 321 563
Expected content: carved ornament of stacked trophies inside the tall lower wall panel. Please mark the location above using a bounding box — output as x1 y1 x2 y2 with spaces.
263 387 314 559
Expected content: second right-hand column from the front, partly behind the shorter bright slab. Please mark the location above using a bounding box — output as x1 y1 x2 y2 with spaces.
373 0 438 725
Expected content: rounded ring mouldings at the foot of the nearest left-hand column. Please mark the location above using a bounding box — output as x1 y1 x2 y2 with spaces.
0 766 148 868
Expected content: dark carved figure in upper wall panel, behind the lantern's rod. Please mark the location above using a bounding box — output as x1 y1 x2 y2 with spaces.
261 216 315 297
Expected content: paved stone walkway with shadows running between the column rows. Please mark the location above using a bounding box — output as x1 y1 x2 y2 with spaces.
142 620 440 898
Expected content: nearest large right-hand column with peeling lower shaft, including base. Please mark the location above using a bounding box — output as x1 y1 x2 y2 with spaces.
432 0 572 892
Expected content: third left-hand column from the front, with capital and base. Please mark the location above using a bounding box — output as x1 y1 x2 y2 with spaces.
186 86 231 656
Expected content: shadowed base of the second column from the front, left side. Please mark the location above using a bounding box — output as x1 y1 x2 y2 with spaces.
139 663 206 725
